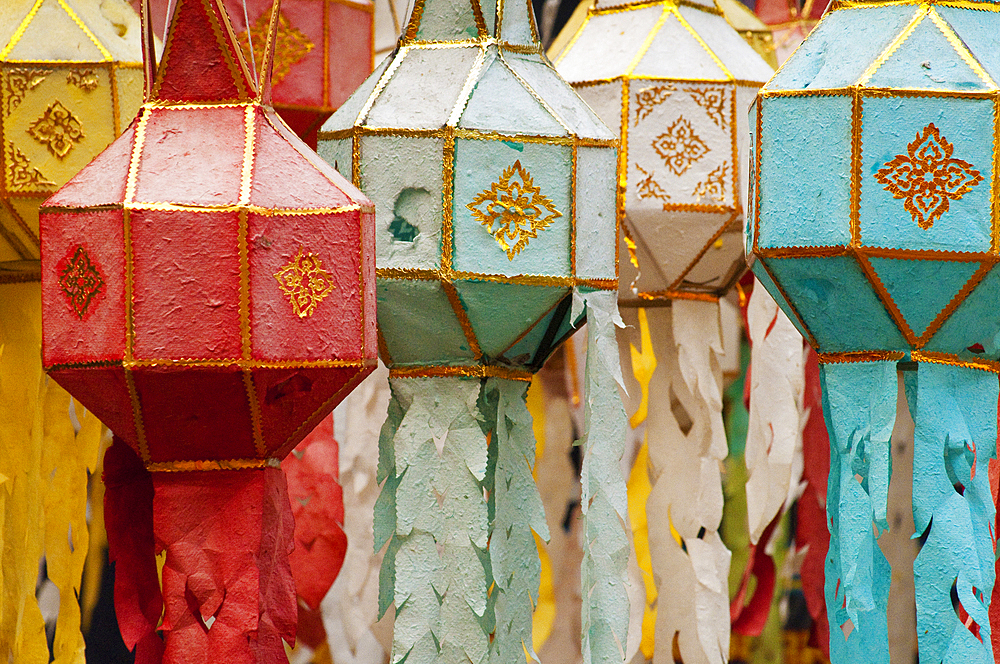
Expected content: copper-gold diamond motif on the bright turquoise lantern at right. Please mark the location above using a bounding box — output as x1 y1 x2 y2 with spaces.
875 122 983 230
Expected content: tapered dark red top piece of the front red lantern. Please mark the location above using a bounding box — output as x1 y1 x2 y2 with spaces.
146 0 256 103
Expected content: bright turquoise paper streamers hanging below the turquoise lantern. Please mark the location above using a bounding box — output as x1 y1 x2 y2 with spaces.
821 361 1000 664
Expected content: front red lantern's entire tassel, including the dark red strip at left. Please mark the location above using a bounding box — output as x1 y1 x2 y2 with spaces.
104 440 297 664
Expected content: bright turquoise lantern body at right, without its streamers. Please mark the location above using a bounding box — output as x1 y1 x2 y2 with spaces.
746 3 1000 359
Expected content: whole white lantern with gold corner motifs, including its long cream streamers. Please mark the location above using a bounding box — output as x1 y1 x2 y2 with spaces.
556 0 771 662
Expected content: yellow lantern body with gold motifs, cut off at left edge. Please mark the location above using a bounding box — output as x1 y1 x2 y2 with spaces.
0 0 142 283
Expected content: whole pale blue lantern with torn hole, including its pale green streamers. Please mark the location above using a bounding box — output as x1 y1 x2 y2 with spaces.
319 0 628 664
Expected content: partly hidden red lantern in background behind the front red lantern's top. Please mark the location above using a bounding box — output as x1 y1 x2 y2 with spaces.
130 0 375 149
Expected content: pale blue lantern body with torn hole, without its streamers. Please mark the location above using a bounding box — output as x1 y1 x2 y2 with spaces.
319 0 616 369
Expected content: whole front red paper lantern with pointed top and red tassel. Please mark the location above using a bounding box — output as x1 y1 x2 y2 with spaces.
42 0 376 662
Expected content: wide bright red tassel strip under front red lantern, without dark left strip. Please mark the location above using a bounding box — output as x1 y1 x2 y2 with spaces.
152 468 298 664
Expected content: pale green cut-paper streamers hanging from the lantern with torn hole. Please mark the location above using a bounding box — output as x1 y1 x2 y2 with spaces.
375 292 628 664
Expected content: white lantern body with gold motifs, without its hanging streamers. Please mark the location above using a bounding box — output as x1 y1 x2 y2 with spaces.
556 0 771 300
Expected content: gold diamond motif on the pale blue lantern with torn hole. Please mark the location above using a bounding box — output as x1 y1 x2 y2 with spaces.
465 160 562 260
